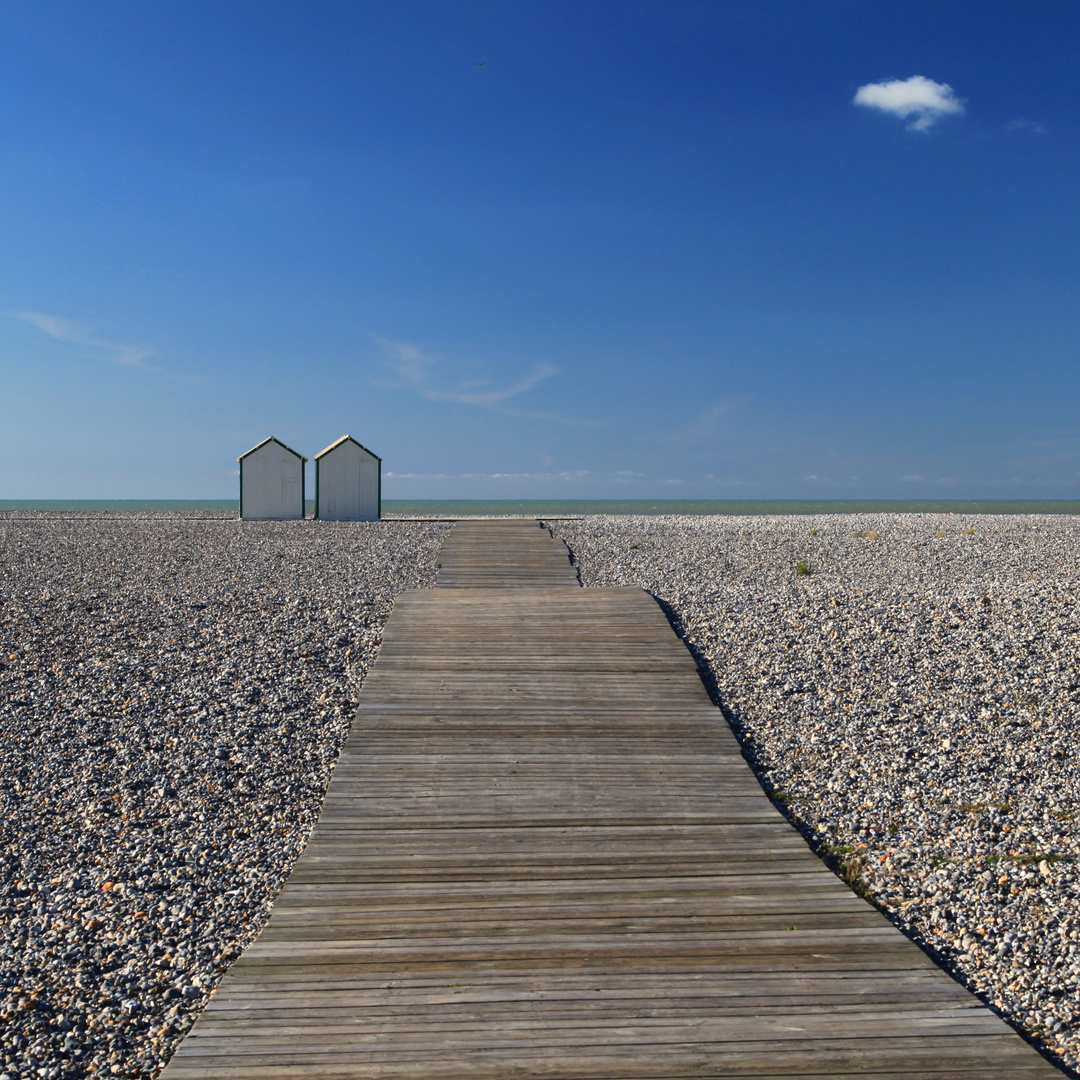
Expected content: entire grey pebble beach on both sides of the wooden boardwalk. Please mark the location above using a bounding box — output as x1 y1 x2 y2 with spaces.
0 514 1080 1080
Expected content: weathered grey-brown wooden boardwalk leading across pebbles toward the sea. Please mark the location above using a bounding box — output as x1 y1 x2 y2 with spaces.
163 522 1061 1080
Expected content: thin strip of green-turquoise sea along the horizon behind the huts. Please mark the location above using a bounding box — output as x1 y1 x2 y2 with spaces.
0 499 1080 517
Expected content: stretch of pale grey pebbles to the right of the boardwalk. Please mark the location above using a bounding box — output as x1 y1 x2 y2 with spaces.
549 514 1080 1069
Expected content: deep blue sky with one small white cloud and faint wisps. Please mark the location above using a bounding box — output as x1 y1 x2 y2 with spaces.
0 0 1080 499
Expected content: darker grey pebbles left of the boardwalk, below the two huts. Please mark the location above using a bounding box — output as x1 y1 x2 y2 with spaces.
0 514 449 1080
